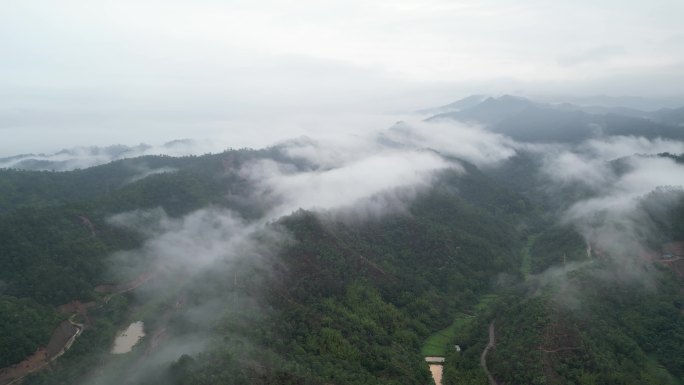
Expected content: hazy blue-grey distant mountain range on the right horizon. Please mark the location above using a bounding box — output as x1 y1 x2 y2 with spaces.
427 95 684 143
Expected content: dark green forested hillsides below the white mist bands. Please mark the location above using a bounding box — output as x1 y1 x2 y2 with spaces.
0 150 684 385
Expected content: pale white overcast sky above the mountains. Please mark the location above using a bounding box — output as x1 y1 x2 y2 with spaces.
0 0 684 155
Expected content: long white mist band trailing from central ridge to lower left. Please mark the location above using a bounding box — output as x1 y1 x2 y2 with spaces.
77 118 513 384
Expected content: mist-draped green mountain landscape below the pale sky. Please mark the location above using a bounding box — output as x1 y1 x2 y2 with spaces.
0 96 684 384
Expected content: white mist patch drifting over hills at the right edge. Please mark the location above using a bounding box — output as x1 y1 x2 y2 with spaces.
526 136 684 308
